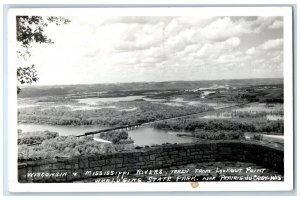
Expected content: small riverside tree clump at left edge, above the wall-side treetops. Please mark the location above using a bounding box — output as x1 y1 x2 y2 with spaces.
18 131 58 145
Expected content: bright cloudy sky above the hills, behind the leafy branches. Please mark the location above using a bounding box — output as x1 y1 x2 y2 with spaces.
18 16 283 85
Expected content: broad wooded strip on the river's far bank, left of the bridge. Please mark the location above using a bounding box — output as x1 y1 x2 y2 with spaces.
18 101 212 126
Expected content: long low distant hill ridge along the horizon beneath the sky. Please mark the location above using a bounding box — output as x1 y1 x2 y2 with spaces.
18 78 283 98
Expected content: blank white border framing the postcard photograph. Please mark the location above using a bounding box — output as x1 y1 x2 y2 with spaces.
7 7 293 192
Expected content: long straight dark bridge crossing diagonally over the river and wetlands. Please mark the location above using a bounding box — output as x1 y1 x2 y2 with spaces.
76 103 250 138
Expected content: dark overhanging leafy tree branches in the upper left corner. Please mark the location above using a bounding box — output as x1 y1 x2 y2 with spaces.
16 16 70 94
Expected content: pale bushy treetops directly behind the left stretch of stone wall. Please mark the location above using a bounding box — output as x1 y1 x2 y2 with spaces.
18 136 134 160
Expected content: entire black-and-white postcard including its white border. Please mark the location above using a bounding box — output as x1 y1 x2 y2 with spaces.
9 8 293 191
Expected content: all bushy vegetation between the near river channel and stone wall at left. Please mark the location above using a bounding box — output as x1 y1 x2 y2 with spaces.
18 131 134 160
